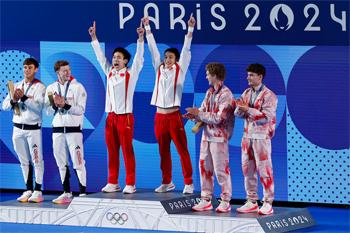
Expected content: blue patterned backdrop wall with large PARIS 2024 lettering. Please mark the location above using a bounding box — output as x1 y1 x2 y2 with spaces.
0 0 350 204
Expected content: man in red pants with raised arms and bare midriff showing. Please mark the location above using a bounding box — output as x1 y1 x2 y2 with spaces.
142 15 196 193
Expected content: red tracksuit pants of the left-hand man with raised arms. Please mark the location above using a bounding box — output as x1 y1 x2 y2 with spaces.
105 113 136 185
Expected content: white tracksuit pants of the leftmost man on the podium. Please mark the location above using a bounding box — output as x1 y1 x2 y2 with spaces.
12 127 44 187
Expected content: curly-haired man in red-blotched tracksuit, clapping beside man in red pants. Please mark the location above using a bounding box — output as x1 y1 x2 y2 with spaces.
184 62 235 212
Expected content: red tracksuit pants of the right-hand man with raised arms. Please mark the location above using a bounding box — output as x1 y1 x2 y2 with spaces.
154 110 193 185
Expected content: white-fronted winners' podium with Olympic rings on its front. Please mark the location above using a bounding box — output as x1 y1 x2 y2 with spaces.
0 189 316 232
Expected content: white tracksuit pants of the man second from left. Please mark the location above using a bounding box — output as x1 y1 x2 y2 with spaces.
52 133 86 187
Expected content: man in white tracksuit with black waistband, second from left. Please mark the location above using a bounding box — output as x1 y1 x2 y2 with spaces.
45 60 87 204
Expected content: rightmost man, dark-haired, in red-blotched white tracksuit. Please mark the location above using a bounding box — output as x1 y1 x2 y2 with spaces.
235 63 278 214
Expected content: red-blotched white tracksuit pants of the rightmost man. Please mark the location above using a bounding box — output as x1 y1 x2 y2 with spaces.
242 138 275 204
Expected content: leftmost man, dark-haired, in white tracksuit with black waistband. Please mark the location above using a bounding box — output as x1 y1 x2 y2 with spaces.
2 58 46 202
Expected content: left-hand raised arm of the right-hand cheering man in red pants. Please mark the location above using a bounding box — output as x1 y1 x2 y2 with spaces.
141 12 163 72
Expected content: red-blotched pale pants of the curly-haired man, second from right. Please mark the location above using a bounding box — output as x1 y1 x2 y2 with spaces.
199 141 232 202
